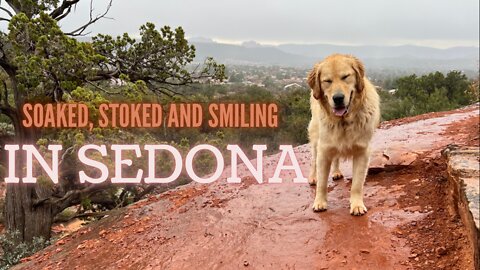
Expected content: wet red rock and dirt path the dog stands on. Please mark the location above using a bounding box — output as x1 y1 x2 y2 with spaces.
18 106 478 269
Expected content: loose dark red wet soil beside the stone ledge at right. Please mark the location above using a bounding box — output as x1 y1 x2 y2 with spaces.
372 157 473 270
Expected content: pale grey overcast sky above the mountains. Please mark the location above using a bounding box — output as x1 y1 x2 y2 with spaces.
2 0 479 48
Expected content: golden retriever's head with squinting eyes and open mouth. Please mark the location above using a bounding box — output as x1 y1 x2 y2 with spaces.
307 54 365 117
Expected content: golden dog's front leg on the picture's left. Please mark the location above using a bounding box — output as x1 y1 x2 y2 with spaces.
313 149 332 212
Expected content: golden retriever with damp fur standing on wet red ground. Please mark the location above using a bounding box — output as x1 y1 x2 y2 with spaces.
307 54 380 215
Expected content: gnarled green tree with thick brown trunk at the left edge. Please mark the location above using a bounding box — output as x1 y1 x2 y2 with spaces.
0 0 224 241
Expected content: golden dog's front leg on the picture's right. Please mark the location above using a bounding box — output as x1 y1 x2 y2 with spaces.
350 149 369 216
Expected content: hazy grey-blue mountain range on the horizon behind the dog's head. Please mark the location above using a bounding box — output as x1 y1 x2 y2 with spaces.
193 41 479 72
